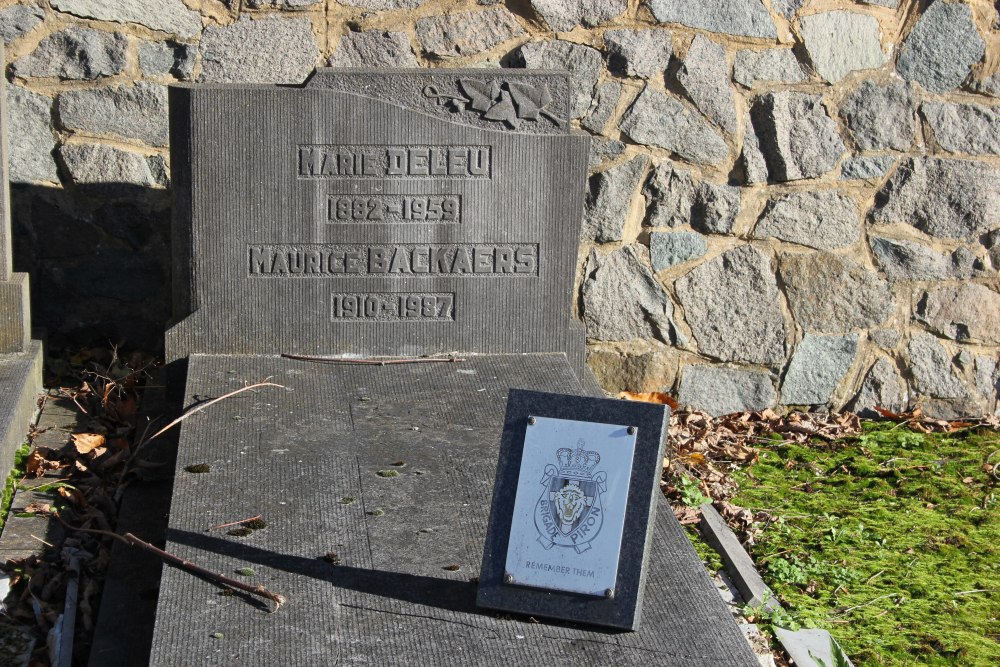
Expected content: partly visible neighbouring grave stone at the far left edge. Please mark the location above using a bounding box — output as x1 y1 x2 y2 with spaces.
0 45 42 488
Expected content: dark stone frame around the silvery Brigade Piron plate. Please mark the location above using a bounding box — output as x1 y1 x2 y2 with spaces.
476 389 670 630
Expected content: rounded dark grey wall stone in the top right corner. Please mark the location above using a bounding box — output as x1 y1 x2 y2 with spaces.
896 0 986 93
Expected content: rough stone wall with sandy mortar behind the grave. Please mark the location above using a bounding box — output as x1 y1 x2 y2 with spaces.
0 0 1000 416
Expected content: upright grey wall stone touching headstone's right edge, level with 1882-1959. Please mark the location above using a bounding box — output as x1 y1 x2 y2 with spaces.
582 155 649 243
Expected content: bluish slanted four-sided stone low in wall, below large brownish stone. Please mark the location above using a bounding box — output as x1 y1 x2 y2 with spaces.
781 334 858 405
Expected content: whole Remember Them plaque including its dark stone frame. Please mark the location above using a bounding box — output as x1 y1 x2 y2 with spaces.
477 389 669 630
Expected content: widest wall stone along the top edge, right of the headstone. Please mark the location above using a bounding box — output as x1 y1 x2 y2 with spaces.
645 0 778 38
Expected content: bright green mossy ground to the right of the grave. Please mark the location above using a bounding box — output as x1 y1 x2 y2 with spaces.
734 423 1000 667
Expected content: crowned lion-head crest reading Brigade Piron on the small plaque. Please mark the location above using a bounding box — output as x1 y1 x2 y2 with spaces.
535 439 607 553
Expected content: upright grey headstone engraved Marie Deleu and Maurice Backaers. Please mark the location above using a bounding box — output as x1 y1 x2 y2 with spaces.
166 69 589 368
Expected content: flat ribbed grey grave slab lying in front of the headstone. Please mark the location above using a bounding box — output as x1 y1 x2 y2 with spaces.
148 354 757 667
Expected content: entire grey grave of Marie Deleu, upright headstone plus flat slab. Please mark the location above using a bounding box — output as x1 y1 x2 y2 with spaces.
109 69 756 666
